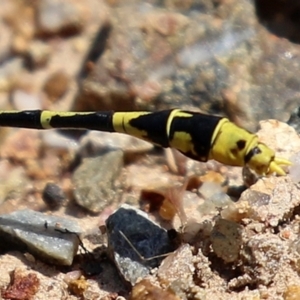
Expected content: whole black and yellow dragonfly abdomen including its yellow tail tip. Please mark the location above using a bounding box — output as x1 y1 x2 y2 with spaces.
0 109 291 176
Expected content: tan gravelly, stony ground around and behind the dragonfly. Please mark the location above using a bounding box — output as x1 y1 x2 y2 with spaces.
0 0 300 300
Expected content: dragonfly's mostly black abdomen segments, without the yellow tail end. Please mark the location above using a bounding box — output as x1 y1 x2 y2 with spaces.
0 109 222 161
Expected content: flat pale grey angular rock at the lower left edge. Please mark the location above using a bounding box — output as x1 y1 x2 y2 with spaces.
0 210 81 266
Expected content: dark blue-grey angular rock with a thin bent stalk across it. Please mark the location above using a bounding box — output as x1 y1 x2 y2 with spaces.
106 205 173 285
